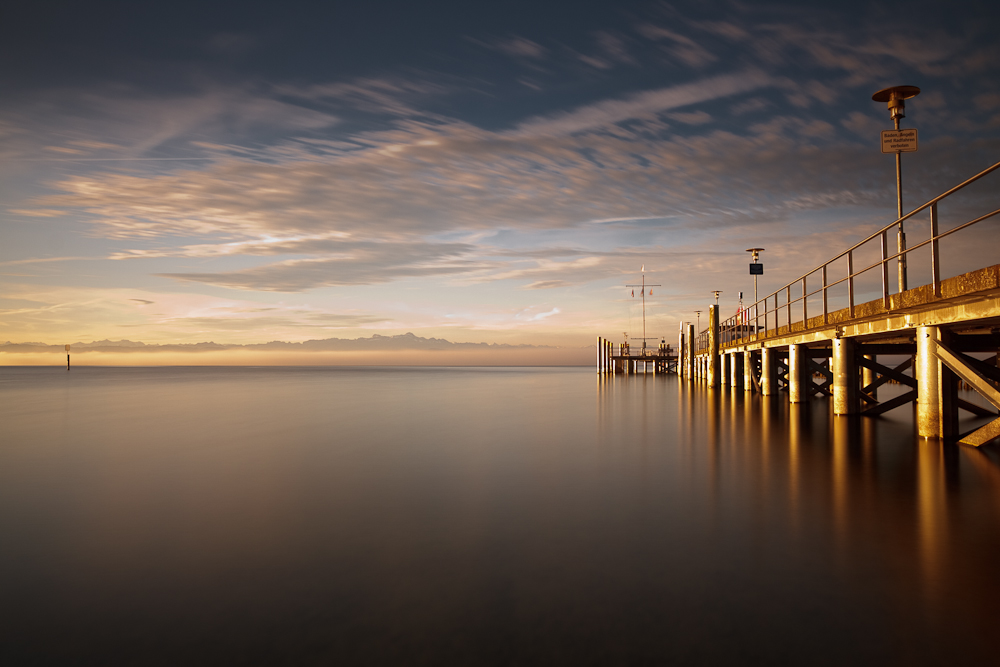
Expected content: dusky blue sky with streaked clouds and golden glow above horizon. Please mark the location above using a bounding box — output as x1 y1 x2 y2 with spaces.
0 0 1000 366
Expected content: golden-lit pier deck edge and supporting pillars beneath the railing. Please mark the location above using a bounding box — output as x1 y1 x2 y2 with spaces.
692 265 1000 446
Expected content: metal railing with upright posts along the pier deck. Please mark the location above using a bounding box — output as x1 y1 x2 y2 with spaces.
695 162 1000 352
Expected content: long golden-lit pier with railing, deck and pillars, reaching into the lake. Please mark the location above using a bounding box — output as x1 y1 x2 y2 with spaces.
598 162 1000 446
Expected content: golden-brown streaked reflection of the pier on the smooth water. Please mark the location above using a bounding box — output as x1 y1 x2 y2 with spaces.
598 375 1000 640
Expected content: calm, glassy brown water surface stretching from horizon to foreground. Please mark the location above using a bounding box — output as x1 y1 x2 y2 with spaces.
0 367 1000 665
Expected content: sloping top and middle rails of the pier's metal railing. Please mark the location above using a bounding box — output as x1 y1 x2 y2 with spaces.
693 162 1000 350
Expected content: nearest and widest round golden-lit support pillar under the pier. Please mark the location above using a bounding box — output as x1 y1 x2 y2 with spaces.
914 327 958 440
